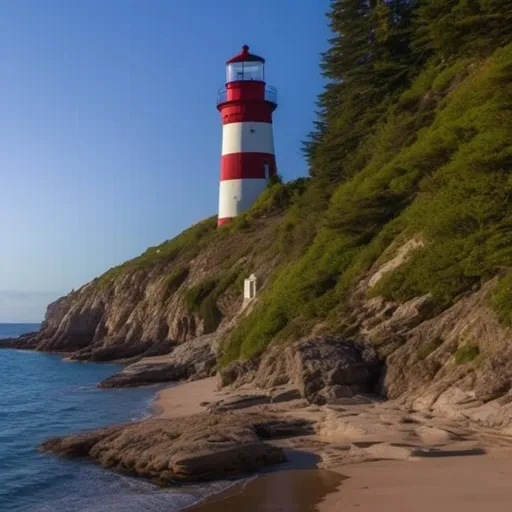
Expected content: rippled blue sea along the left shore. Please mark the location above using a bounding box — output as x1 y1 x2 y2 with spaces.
0 323 231 512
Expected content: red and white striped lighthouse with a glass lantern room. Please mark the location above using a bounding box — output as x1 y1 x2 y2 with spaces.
217 46 277 226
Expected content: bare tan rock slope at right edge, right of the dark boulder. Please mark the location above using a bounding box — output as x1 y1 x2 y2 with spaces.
381 280 512 406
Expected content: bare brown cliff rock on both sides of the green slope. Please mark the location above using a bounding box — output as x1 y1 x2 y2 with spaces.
6 217 512 426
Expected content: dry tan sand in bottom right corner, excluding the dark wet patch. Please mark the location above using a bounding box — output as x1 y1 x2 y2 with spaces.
318 450 512 512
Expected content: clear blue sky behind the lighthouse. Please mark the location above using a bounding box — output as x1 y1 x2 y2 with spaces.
0 0 329 322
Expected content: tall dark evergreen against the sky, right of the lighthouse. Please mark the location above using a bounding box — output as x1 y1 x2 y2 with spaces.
304 0 413 183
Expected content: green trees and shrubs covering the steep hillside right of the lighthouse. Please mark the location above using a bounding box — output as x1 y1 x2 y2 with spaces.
92 0 512 365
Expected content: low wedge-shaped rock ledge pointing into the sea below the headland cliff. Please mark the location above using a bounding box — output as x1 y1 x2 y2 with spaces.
99 335 217 388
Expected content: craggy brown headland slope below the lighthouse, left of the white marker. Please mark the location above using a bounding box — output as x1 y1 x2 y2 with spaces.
0 216 279 366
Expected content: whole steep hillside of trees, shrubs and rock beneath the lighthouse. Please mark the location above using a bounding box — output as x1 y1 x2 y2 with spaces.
6 0 512 423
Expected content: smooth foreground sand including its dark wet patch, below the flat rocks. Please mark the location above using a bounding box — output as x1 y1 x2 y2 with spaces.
187 451 512 512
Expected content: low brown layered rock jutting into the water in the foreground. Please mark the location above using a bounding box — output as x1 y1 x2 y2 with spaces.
40 413 286 484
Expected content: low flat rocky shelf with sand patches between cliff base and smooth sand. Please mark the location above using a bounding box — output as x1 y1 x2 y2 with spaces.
40 372 512 496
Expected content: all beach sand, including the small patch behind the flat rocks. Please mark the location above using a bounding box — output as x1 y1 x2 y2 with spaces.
155 378 512 512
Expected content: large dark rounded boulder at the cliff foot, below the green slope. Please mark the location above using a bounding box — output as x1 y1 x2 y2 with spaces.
221 337 380 404
